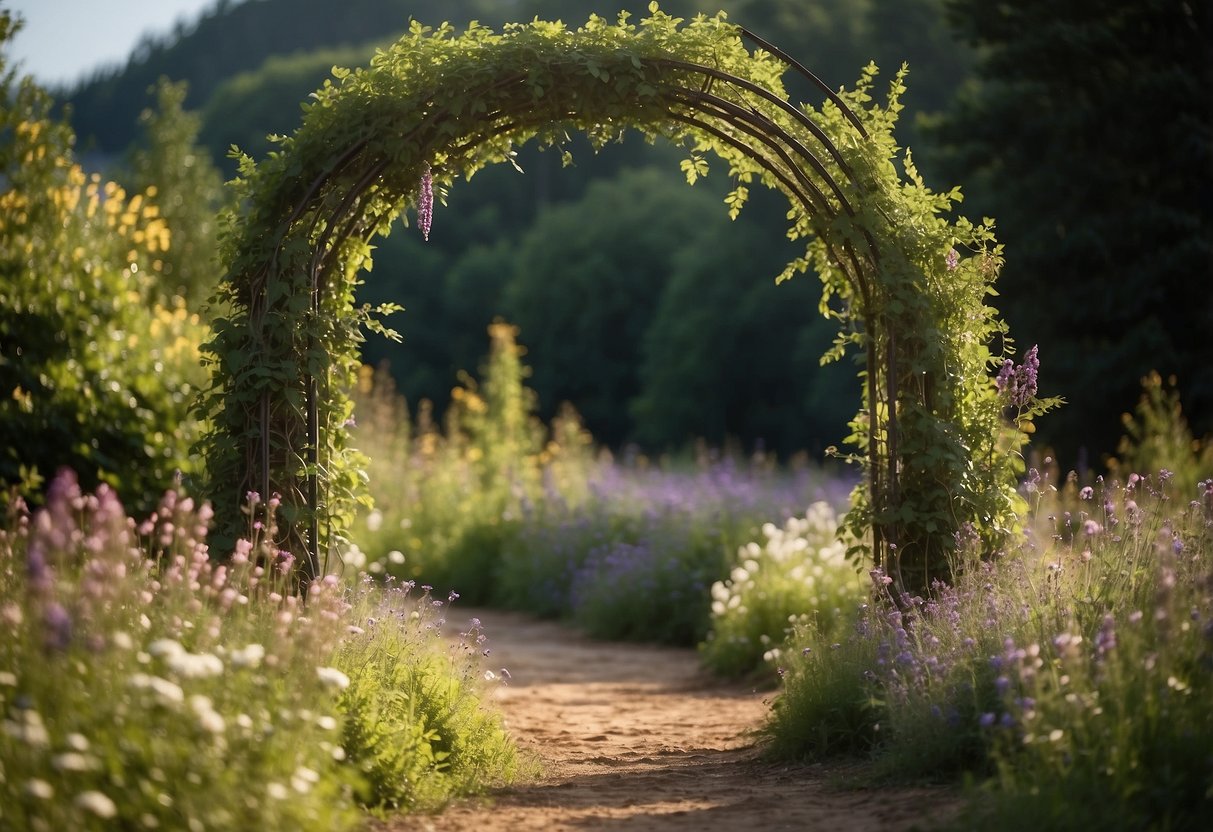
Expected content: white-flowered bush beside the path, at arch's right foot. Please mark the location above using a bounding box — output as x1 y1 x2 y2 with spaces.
701 502 862 676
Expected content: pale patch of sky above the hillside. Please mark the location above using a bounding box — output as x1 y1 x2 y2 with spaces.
0 0 216 86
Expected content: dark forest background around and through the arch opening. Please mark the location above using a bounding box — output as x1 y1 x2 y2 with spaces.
28 0 1213 467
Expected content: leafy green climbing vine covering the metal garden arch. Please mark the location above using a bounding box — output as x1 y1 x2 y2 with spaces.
204 4 1048 587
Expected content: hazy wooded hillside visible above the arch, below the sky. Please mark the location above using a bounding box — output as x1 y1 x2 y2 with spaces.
62 0 967 160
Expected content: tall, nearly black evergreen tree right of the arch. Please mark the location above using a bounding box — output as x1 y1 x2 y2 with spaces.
940 0 1213 465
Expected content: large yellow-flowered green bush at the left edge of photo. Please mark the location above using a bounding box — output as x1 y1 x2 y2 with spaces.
0 43 206 509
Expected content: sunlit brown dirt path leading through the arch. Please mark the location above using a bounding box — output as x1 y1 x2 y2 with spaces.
386 608 955 832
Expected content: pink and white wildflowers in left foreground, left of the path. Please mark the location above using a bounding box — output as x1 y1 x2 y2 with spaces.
0 473 516 830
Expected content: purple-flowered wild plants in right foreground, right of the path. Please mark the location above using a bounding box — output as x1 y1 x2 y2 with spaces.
767 471 1213 830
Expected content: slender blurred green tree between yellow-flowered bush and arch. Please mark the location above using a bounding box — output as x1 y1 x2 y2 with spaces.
130 78 223 309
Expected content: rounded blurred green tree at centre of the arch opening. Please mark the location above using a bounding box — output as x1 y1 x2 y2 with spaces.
502 169 727 446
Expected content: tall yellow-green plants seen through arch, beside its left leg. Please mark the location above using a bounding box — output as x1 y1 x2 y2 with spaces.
346 321 591 604
